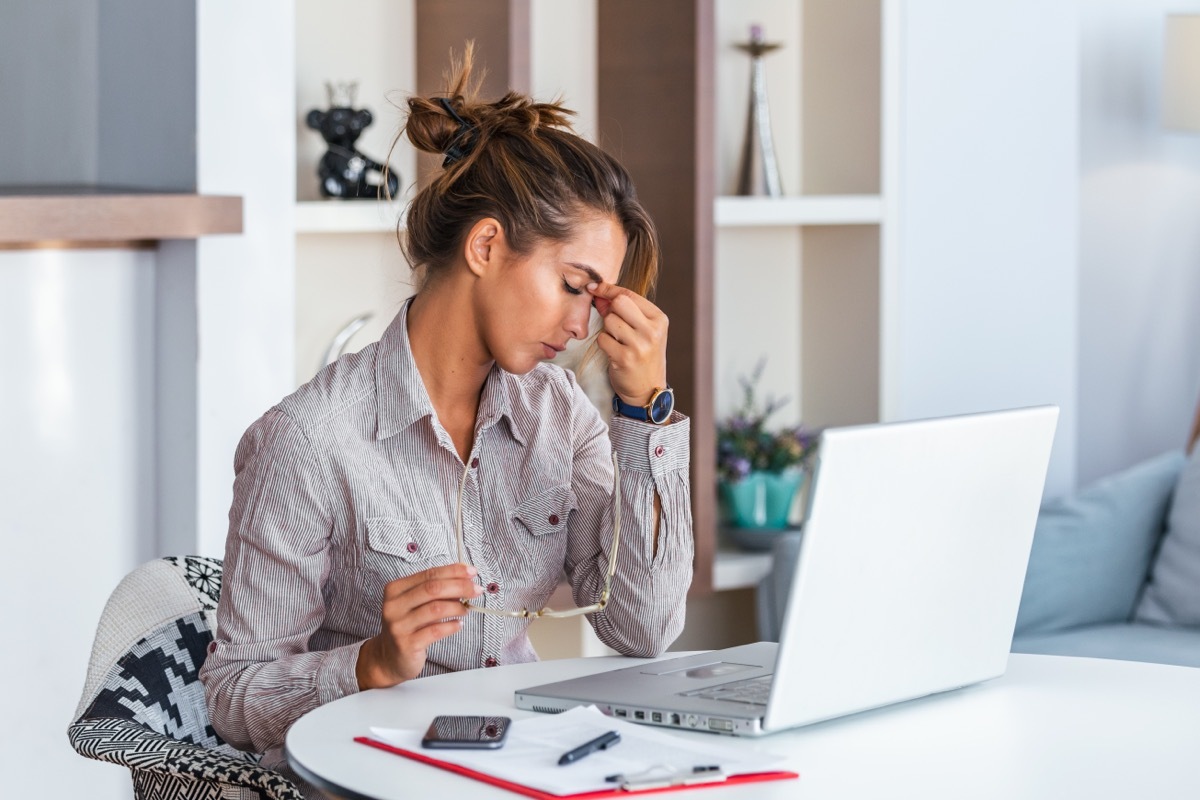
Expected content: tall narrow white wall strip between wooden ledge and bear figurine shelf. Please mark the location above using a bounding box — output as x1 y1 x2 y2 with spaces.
192 0 296 557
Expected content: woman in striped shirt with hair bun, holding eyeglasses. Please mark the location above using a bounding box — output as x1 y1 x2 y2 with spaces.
200 49 692 764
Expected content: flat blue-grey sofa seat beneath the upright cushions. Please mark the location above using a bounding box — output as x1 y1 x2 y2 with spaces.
1013 622 1200 667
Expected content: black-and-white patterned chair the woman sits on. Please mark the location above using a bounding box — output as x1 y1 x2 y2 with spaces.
67 555 302 800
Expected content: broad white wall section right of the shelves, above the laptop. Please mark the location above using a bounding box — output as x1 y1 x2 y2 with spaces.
887 0 1079 494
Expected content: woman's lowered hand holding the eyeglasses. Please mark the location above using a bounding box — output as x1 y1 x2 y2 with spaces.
354 564 484 690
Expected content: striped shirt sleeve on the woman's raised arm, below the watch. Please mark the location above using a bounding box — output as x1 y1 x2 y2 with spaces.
566 386 695 657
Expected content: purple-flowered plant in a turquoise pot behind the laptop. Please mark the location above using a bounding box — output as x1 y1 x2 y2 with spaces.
716 361 816 530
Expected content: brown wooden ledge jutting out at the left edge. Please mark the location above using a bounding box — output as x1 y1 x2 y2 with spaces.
0 186 242 249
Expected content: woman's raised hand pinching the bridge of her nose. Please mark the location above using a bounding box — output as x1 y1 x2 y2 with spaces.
588 283 667 405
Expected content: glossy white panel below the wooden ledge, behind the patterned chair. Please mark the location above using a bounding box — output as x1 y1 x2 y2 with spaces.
0 249 155 798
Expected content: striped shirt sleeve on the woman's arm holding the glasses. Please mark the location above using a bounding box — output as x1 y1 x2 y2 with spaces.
200 410 361 752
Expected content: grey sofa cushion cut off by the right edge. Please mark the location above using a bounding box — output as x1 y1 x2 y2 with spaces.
1136 447 1200 625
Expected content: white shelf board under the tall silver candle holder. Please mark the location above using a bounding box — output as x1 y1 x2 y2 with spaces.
713 194 883 228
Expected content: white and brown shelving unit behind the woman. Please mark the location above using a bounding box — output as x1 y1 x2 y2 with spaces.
295 0 895 594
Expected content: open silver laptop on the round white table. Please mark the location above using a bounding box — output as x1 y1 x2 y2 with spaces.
516 407 1058 736
